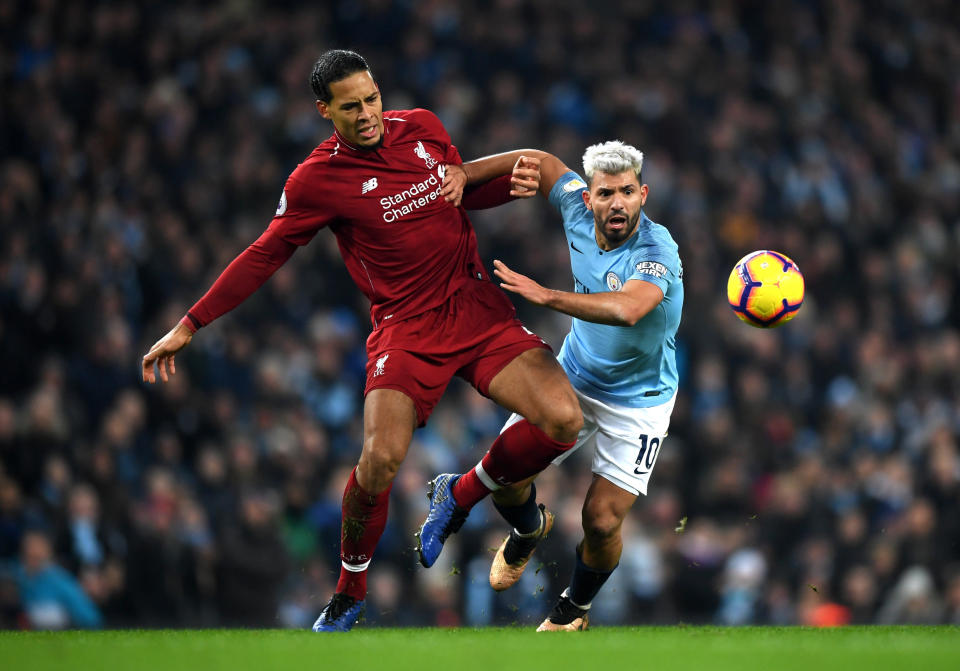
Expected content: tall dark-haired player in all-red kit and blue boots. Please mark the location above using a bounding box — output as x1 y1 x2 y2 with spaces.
143 50 583 631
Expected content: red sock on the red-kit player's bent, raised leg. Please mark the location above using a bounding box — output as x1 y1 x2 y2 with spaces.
451 419 574 508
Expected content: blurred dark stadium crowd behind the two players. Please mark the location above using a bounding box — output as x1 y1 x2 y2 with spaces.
0 0 960 628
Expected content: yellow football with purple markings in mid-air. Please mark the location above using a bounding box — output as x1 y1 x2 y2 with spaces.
727 250 804 329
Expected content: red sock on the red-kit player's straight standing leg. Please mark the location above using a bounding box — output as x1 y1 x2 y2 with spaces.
336 468 393 599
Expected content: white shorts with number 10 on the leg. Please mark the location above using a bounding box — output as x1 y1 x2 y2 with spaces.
501 388 677 495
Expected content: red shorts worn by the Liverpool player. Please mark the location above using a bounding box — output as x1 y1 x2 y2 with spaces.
364 280 552 426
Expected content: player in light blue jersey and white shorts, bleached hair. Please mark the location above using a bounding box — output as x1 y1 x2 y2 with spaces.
478 141 683 631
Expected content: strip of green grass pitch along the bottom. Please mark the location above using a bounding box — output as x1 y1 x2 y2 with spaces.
0 626 960 671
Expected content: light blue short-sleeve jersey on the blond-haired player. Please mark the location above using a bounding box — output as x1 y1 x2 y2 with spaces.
550 172 683 408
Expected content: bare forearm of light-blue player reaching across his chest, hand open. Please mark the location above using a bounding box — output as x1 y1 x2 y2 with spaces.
493 260 663 326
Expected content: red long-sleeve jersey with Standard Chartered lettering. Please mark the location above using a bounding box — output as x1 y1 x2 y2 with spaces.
184 109 509 330
